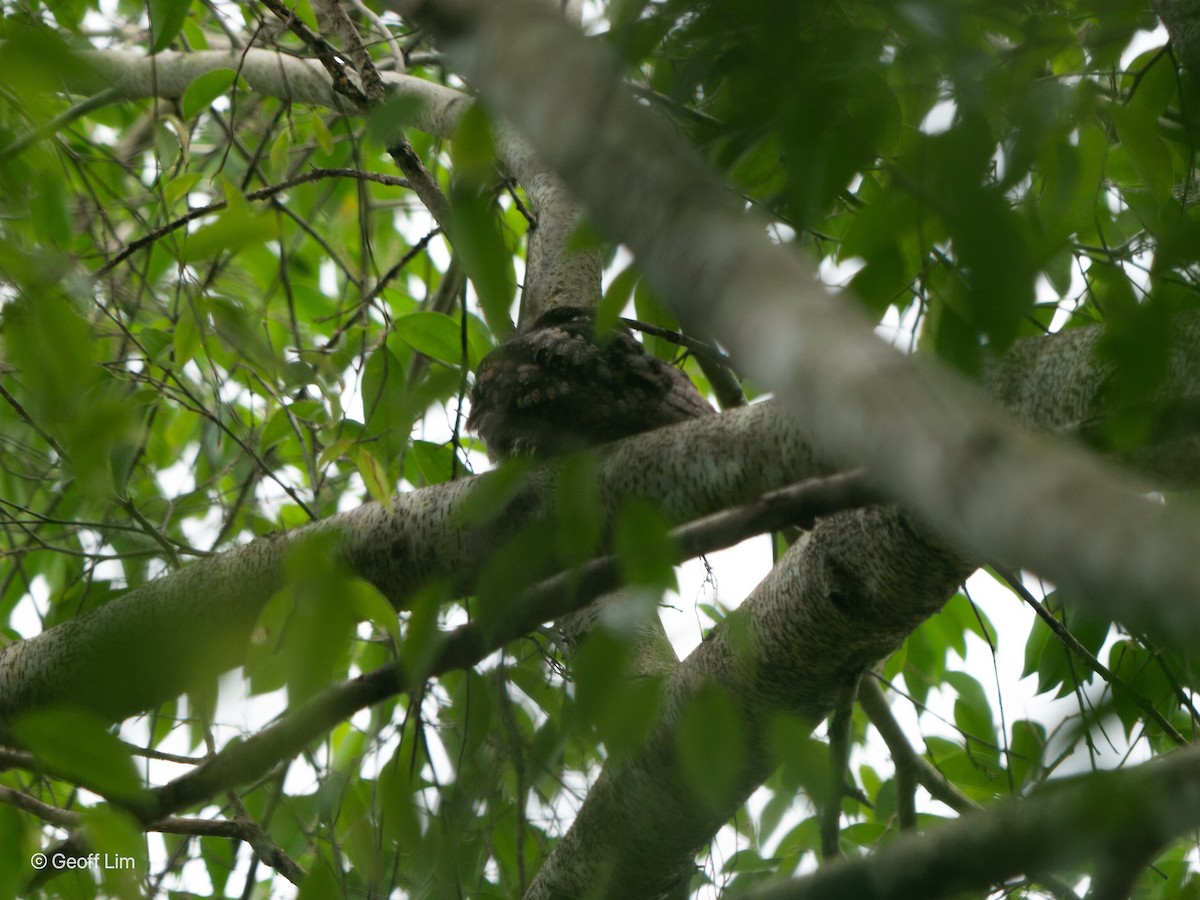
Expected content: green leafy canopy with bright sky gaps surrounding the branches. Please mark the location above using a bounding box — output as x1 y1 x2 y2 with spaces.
0 0 1200 898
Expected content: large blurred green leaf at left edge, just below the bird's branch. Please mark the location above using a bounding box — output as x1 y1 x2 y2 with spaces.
12 707 142 800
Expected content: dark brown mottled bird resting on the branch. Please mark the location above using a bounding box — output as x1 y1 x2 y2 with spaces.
467 306 713 458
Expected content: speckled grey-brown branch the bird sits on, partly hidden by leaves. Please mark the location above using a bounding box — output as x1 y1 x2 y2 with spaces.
0 406 829 721
